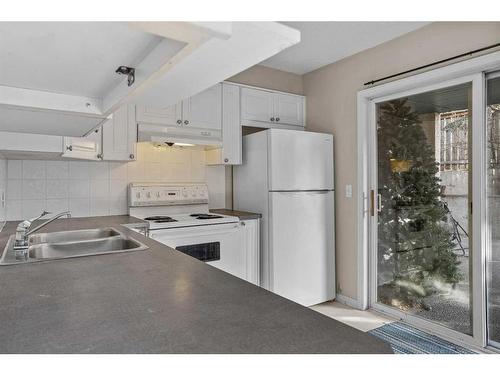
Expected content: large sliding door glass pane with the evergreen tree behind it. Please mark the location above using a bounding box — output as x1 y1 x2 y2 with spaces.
377 83 472 335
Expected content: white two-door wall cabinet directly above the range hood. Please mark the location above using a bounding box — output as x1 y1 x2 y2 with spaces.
136 83 222 131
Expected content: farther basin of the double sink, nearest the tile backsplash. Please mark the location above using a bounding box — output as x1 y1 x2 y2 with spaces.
29 228 120 245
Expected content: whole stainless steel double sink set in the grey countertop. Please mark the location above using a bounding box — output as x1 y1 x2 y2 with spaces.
0 228 148 265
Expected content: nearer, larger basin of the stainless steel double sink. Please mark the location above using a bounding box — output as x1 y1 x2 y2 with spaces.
28 237 146 259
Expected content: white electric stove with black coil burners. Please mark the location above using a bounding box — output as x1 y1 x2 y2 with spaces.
129 183 259 284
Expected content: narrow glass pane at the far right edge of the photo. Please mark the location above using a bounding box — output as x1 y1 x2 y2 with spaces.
486 78 500 345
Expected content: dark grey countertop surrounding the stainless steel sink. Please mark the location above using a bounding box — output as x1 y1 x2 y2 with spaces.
0 216 392 353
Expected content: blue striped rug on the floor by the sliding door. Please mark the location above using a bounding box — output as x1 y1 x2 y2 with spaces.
368 322 474 354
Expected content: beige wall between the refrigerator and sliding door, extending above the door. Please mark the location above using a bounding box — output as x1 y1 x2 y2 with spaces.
304 22 500 298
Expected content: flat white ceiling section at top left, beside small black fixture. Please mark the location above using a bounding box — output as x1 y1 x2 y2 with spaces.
0 22 169 98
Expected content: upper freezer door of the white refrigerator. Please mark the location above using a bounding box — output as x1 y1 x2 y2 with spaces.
268 129 333 191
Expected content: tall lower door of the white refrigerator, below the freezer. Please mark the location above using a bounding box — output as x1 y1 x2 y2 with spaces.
268 191 335 306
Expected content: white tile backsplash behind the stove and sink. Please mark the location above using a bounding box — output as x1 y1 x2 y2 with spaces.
0 143 225 222
